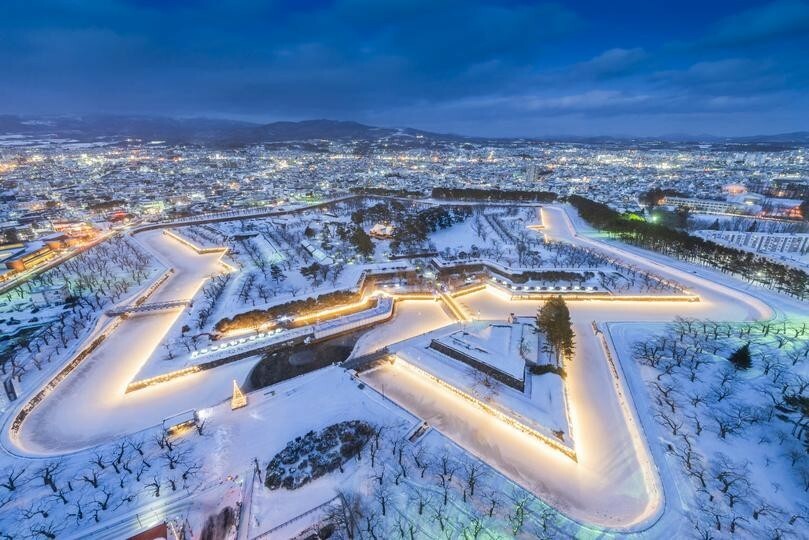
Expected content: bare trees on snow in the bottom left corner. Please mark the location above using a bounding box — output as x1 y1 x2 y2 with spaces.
0 424 204 540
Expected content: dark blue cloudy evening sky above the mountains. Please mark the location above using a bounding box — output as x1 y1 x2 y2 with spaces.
0 0 809 135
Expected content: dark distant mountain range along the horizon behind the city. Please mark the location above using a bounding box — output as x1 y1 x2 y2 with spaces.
0 115 809 146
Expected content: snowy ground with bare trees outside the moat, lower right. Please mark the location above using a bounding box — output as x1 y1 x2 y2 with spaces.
605 319 809 538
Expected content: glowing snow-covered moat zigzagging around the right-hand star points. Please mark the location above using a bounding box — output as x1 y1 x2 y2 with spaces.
348 208 788 527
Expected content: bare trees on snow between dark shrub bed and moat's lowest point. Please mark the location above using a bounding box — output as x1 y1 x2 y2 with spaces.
310 428 570 540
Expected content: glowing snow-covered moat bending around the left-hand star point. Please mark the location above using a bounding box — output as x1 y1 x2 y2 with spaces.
10 231 251 455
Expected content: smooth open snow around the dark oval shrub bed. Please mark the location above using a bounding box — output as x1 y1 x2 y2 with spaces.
191 367 417 538
